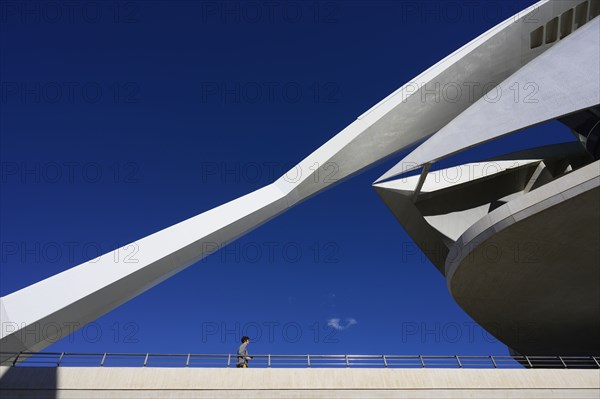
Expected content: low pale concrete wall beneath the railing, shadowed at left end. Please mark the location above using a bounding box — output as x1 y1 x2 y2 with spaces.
0 367 600 399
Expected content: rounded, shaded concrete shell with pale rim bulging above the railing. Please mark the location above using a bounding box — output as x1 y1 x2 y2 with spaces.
446 161 600 356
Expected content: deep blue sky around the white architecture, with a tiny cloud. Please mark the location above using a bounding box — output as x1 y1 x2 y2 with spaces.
0 0 572 355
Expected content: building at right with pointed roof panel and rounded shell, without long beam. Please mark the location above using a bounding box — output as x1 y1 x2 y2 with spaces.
374 2 600 355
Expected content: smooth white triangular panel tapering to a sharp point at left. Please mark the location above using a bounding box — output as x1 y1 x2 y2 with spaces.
377 17 600 182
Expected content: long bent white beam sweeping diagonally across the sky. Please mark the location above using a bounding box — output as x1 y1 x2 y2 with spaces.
0 0 577 361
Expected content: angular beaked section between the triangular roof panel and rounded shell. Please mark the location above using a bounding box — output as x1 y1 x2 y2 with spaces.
373 141 593 278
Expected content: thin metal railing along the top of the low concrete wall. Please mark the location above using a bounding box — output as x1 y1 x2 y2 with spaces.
0 352 600 369
